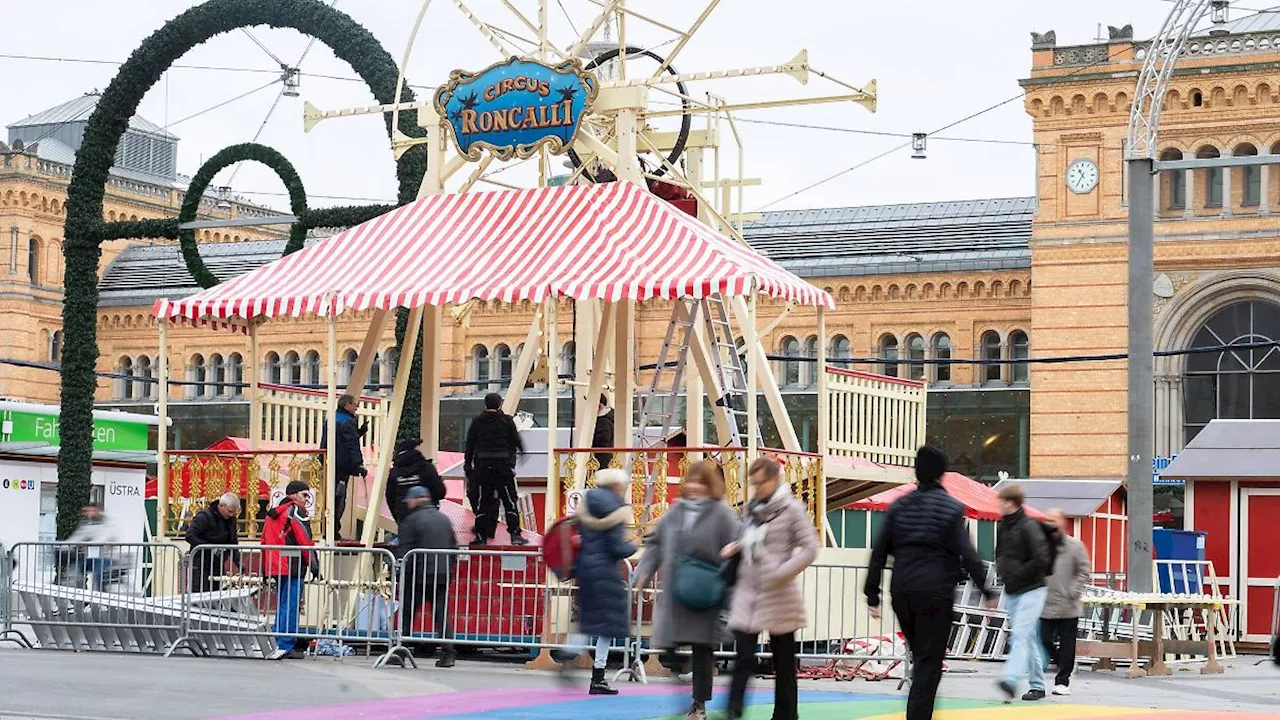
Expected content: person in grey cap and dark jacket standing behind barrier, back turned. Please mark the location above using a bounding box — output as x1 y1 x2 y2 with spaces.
397 486 458 667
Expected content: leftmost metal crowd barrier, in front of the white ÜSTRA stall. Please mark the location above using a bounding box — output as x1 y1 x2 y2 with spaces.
5 542 183 652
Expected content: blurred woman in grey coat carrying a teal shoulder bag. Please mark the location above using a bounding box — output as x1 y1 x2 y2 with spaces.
635 460 741 720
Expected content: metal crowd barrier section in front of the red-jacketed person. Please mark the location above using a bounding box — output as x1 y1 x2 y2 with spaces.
180 544 399 665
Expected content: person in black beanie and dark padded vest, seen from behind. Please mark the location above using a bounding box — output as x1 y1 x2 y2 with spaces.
863 446 996 720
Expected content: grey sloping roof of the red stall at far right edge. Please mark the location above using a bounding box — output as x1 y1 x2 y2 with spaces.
1160 420 1280 480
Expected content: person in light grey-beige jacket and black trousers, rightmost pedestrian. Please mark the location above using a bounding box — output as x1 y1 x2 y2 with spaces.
1041 509 1093 696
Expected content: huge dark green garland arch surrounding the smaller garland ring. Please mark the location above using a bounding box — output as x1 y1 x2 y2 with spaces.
58 0 426 538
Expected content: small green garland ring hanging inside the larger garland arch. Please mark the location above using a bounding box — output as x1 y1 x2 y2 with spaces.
178 142 307 288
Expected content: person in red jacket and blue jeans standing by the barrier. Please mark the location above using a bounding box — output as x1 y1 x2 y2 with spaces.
262 480 320 660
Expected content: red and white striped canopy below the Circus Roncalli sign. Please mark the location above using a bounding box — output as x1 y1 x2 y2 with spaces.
155 182 835 322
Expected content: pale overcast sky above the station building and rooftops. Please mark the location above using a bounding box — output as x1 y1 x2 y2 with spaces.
0 0 1239 211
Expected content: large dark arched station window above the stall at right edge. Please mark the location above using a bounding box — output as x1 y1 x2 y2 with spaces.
1183 300 1280 442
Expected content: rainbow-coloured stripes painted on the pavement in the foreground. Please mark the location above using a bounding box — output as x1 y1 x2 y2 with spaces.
223 685 1280 720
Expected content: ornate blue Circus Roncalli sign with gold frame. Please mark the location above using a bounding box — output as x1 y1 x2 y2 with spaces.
435 58 599 160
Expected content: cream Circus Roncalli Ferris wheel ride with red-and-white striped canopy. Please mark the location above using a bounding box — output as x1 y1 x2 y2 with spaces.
155 0 925 546
